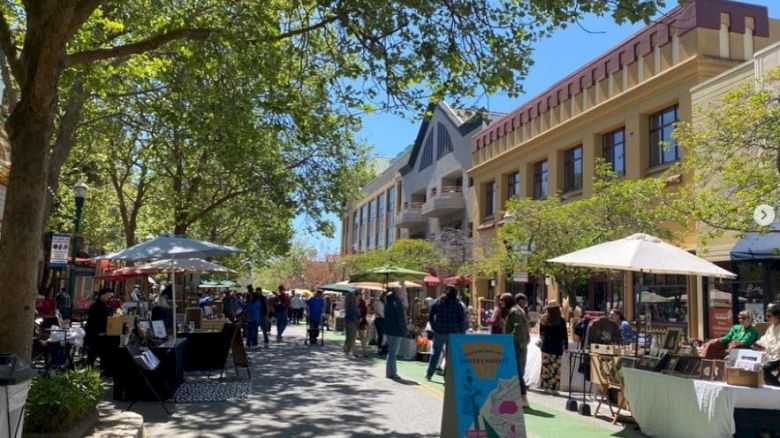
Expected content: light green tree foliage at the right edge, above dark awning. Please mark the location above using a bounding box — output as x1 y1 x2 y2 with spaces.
670 70 780 240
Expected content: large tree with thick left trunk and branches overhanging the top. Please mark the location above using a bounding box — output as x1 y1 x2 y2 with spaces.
0 0 663 357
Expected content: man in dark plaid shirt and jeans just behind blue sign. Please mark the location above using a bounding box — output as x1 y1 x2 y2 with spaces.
425 286 466 380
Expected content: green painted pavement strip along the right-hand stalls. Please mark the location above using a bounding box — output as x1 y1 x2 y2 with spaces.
325 331 621 438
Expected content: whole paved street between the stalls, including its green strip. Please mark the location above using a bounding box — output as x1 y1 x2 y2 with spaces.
103 326 642 438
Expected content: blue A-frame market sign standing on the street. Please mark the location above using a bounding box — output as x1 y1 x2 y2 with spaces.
441 335 526 438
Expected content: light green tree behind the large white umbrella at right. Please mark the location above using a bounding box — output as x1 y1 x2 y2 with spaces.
497 162 686 300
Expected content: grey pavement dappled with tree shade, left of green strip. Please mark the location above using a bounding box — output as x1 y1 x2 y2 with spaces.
101 328 438 438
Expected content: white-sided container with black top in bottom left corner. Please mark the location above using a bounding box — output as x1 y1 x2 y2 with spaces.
0 354 35 438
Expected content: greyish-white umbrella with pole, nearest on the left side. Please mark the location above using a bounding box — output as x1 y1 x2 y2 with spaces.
95 234 242 341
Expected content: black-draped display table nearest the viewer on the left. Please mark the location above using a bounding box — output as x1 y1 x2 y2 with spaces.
114 339 187 400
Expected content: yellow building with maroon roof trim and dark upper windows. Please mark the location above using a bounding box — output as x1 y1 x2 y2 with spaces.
469 0 780 336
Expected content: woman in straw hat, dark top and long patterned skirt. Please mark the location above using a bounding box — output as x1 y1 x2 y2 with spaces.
539 300 569 392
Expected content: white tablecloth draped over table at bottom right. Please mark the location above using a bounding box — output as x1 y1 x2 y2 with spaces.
623 368 780 438
